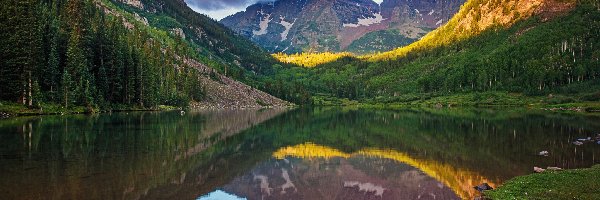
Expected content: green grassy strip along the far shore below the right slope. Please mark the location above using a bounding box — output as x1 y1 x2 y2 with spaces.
313 92 600 114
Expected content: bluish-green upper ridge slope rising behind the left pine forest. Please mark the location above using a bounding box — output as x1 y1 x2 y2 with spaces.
132 0 276 76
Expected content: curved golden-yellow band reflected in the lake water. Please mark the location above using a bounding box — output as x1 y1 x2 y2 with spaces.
273 143 497 199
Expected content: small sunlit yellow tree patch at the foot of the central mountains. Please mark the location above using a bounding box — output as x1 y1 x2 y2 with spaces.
273 52 352 68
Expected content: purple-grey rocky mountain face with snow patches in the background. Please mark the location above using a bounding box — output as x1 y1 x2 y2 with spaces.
221 0 464 54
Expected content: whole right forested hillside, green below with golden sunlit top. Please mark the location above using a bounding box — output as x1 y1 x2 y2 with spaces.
268 0 600 105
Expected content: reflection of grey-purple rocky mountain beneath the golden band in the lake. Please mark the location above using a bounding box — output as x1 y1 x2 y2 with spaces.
222 145 459 199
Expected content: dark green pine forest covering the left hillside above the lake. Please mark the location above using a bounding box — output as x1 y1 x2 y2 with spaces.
0 0 203 110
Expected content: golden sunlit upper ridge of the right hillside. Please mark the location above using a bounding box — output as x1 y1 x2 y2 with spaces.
365 0 577 61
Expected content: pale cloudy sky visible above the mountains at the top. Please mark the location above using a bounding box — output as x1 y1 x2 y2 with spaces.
185 0 383 20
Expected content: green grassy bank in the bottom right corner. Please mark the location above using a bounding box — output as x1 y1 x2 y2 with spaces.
485 165 600 199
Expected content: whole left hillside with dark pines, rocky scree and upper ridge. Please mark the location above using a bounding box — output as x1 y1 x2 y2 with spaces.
0 0 287 112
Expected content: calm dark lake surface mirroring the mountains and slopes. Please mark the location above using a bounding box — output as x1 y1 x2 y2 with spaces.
0 108 600 199
